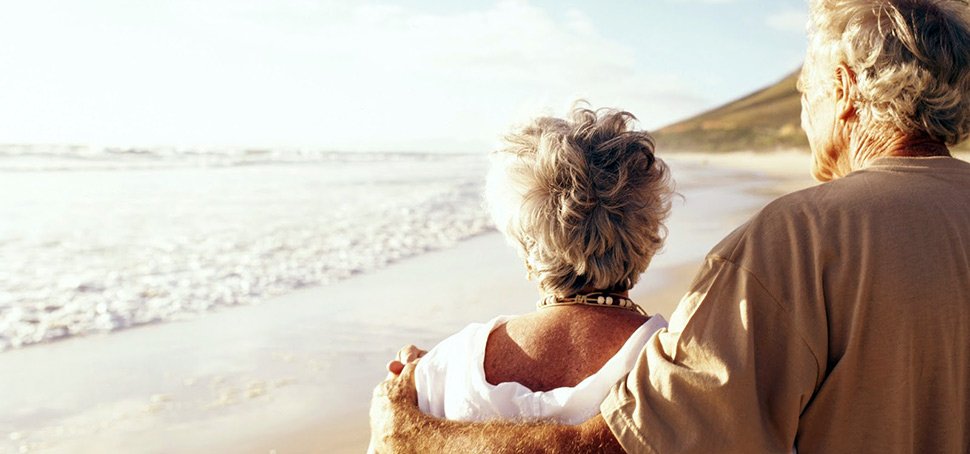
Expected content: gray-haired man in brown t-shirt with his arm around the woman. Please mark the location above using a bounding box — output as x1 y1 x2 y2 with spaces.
371 0 970 453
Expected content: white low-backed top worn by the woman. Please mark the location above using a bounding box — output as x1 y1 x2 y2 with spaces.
414 315 667 424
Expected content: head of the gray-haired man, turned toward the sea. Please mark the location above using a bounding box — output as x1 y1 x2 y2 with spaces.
799 0 970 181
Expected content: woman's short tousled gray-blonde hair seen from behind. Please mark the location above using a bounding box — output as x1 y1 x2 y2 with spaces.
486 108 672 296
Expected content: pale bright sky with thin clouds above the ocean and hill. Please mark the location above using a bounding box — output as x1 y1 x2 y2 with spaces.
0 0 808 152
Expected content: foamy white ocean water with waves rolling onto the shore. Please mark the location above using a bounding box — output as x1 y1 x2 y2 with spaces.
0 146 490 351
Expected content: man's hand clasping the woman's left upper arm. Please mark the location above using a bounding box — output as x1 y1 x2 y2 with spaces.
367 356 423 453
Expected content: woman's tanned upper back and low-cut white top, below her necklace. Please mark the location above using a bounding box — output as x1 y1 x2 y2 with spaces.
414 306 666 424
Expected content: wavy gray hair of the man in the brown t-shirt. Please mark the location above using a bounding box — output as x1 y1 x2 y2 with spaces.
802 0 970 145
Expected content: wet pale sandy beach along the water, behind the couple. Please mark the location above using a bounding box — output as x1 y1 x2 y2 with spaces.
0 153 813 453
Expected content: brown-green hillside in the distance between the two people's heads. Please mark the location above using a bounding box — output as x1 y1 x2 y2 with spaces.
654 71 970 151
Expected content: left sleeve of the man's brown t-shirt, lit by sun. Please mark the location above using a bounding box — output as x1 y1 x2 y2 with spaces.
600 256 819 453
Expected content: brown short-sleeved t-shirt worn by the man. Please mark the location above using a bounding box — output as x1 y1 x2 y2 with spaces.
600 158 970 453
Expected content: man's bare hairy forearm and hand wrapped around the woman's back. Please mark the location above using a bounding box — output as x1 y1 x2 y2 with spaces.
370 363 624 453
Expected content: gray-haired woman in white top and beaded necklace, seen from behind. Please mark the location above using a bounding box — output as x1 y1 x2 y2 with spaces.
386 108 671 430
